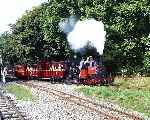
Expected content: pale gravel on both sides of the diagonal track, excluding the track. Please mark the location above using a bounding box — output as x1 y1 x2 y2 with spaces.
2 81 149 120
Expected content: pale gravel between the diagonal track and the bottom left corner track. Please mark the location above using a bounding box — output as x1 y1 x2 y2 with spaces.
17 86 108 120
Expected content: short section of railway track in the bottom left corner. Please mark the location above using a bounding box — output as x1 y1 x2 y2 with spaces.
0 89 26 120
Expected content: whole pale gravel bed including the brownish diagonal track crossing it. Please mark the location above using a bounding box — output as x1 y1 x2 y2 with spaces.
0 81 148 120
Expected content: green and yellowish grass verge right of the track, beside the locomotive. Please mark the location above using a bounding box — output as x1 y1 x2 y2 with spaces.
75 77 150 117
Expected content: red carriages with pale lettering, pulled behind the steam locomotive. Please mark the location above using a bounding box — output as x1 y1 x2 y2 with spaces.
15 62 65 78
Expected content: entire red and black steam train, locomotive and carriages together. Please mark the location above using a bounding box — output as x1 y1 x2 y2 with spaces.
15 61 113 85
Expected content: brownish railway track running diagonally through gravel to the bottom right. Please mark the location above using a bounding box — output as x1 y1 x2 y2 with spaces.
18 82 144 120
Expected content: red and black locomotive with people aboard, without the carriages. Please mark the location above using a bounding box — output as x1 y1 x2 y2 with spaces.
79 56 112 85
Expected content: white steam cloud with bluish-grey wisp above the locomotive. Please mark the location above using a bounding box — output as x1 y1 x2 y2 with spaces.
60 18 106 54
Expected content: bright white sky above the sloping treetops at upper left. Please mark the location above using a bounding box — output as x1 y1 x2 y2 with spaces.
0 0 48 34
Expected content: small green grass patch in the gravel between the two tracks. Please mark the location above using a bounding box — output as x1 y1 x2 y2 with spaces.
6 84 36 101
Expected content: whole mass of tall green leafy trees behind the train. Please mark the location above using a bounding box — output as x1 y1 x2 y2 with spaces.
1 0 150 74
